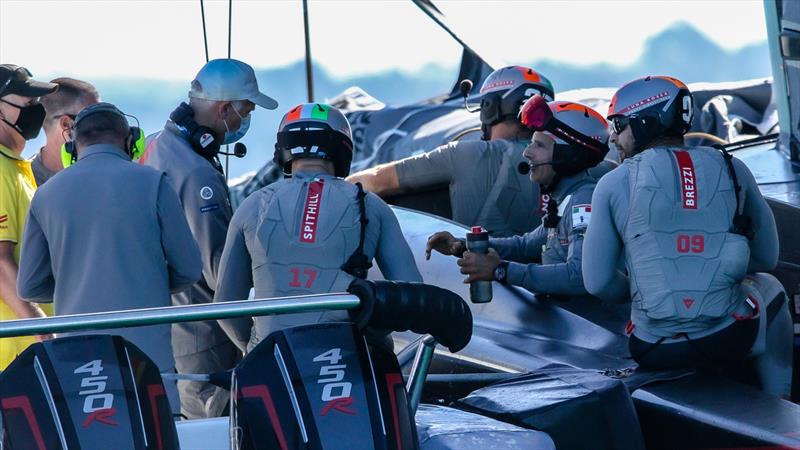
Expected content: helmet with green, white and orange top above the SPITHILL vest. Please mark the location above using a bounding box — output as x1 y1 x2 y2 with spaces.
273 103 353 178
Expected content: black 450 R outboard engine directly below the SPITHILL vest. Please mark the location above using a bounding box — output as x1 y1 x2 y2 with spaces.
231 323 418 450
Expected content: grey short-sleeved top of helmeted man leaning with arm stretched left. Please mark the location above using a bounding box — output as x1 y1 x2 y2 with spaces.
395 139 541 236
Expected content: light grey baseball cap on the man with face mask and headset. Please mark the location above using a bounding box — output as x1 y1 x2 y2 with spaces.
189 59 278 109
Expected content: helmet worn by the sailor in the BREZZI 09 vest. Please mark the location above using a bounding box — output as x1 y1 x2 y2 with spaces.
608 76 694 151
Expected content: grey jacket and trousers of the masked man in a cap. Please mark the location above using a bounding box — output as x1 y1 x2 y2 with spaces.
139 121 240 419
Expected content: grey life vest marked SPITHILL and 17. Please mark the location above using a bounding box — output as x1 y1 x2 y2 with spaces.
253 178 371 298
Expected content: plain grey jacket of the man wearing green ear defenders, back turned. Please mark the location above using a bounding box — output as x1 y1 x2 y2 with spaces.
17 145 201 370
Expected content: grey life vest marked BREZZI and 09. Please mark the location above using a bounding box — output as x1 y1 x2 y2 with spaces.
623 147 750 336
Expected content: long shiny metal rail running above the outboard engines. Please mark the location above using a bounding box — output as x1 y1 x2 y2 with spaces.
0 293 361 338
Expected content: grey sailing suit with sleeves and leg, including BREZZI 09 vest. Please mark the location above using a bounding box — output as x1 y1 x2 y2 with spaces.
583 147 791 392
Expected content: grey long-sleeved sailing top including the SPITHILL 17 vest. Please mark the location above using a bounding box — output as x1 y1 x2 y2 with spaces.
214 172 422 349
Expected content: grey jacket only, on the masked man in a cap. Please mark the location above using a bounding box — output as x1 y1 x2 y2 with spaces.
139 121 234 356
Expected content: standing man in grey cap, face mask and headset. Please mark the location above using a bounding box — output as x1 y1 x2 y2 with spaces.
139 59 278 419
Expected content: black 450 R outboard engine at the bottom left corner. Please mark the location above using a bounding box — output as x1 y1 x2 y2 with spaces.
0 335 179 450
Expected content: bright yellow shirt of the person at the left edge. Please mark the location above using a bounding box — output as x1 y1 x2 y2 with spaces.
0 145 53 370
